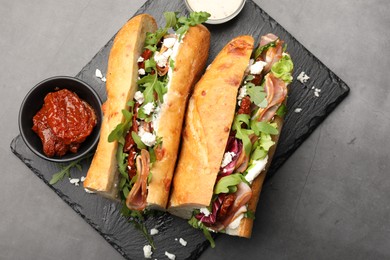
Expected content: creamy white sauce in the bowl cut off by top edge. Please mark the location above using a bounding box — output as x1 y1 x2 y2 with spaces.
187 0 243 20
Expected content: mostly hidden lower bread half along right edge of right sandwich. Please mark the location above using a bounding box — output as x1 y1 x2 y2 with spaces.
226 115 283 238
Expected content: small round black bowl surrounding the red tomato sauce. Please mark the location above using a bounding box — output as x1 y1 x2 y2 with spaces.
19 76 103 163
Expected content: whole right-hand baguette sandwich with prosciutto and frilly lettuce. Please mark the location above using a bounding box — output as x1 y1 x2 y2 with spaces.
168 34 293 240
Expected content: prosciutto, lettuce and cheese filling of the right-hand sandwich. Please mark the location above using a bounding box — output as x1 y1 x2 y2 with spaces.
189 34 293 242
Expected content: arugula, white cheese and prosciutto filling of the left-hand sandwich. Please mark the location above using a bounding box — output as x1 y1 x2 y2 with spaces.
108 12 209 212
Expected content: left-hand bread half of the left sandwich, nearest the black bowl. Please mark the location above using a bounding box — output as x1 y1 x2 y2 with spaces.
84 14 157 198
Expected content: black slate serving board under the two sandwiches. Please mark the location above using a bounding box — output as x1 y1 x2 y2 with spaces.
11 0 349 259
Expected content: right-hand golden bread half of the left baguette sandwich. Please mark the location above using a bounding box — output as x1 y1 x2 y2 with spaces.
147 25 210 210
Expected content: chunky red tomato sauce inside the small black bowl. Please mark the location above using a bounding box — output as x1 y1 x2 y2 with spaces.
32 89 97 157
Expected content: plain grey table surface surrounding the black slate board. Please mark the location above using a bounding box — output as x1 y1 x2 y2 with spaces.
0 0 390 260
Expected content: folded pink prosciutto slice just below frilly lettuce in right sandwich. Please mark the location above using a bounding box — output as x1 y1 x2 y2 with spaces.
255 73 287 122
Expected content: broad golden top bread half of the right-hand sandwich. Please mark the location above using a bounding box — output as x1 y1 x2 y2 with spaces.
168 35 254 218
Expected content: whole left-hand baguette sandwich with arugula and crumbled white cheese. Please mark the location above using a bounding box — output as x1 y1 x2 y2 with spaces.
84 12 210 211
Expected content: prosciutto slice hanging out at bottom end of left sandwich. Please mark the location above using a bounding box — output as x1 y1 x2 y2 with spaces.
126 149 150 210
